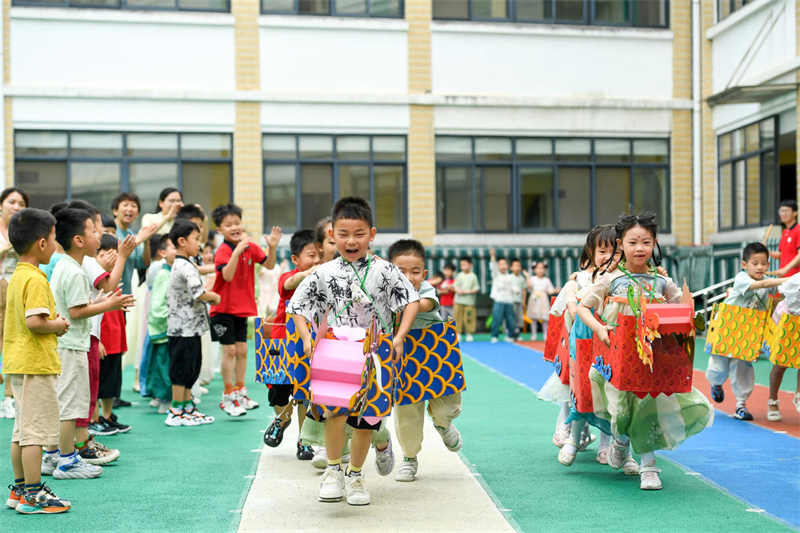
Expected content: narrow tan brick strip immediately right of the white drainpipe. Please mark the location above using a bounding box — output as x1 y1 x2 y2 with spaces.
700 2 717 242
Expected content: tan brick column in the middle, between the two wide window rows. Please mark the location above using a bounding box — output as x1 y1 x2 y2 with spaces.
405 0 436 246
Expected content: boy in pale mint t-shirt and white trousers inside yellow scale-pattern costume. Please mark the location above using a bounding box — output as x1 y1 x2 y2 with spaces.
706 242 787 420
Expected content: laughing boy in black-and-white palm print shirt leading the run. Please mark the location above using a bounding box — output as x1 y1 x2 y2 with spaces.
286 197 419 505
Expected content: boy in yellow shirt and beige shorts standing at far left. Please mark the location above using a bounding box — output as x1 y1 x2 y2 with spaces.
3 208 71 514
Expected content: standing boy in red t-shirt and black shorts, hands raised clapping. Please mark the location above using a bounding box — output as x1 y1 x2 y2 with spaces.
209 204 282 416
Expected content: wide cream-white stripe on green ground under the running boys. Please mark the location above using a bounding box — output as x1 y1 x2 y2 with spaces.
239 417 514 533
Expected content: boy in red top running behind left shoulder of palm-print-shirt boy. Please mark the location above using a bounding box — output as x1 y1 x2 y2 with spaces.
264 229 320 461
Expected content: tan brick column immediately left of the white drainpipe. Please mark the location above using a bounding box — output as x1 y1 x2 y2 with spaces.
670 2 694 245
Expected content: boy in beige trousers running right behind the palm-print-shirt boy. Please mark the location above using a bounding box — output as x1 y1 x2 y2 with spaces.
388 239 461 482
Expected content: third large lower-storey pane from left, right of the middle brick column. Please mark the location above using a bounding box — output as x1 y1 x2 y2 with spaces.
519 167 556 230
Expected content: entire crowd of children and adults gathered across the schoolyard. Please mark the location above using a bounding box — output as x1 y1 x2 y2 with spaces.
0 183 800 514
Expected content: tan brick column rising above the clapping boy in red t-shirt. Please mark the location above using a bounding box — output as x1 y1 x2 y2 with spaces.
231 0 264 233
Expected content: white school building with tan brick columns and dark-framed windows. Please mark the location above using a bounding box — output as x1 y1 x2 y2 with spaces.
0 0 800 287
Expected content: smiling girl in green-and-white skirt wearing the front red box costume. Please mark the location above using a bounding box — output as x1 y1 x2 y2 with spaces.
576 214 714 490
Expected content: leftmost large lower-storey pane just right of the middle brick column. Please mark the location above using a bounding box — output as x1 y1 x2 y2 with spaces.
437 167 475 231
